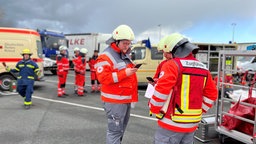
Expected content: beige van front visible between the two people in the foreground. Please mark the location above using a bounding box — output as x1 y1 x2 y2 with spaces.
131 44 164 85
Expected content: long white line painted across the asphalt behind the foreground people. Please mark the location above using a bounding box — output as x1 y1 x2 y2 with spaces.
33 96 157 121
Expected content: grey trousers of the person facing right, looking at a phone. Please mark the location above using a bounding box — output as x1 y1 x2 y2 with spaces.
103 102 131 144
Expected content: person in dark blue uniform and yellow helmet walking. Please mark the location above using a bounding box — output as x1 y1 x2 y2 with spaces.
6 49 41 109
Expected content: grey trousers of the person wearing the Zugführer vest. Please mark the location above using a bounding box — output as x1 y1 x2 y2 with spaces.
154 126 195 144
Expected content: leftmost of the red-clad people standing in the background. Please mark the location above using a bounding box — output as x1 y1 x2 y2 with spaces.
56 45 69 98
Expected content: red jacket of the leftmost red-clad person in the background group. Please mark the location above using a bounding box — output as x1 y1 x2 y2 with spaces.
56 54 69 75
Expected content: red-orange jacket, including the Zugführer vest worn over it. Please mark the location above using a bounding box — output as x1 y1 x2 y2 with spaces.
149 54 217 132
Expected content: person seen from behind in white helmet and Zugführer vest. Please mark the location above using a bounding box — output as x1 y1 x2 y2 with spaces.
149 33 217 144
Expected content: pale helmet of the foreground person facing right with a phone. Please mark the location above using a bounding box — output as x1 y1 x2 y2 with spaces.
112 25 135 41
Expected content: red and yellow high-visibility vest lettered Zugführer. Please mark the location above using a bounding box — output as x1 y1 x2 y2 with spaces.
166 58 208 123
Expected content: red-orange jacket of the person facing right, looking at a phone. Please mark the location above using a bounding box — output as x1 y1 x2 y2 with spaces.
95 43 138 103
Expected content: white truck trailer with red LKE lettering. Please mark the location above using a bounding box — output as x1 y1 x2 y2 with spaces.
65 33 111 70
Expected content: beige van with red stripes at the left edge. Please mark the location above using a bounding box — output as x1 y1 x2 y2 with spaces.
0 27 44 91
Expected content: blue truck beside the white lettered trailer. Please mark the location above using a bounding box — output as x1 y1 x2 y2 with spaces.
37 29 68 75
